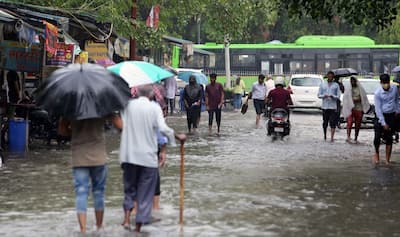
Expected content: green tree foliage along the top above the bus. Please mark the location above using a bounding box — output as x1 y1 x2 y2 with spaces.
9 0 400 49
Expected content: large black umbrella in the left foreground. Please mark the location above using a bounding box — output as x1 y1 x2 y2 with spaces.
36 64 130 120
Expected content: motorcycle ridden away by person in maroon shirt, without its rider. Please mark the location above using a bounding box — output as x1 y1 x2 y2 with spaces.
266 108 290 139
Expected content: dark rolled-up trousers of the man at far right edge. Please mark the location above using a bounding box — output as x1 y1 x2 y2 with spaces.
374 113 396 153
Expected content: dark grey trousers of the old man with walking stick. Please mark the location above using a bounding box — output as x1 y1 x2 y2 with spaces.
121 163 158 223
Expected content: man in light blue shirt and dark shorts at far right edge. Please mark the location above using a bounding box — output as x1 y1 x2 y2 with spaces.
374 74 400 164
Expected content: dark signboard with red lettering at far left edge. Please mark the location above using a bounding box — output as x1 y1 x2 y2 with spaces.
0 41 41 72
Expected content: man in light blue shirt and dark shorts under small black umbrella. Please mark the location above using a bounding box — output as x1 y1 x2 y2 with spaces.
318 71 340 142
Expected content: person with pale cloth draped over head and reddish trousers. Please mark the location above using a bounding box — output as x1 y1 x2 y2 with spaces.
342 77 370 142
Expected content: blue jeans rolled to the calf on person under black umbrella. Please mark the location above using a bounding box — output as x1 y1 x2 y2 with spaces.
72 165 107 213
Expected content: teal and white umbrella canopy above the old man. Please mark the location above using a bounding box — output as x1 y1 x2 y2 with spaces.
107 61 174 87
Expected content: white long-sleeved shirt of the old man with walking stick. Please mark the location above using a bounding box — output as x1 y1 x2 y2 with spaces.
119 97 176 168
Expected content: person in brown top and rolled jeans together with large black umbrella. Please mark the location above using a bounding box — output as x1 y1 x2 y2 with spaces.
36 64 130 233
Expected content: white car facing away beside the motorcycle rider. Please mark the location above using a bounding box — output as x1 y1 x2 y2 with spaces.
288 74 323 109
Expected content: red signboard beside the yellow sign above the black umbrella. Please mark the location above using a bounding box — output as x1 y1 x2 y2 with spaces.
46 43 74 66
